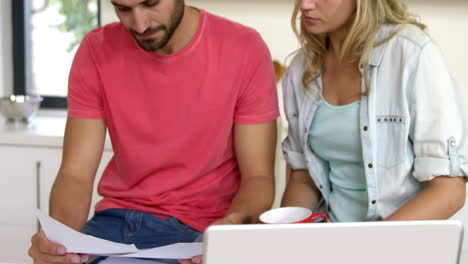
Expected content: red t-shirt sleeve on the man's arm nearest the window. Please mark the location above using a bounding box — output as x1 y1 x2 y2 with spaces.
67 35 104 119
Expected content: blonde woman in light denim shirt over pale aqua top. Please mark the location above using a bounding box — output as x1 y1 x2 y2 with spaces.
282 0 468 222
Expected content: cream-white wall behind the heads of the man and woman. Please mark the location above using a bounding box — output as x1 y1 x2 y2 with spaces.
101 0 468 95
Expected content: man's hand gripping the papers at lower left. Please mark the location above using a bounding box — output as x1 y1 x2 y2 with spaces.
28 232 89 264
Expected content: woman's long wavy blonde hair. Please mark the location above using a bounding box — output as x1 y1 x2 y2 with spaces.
291 0 426 94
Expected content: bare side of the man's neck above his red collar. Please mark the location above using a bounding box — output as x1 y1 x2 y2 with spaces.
155 6 200 55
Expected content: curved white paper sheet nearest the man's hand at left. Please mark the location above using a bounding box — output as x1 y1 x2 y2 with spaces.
36 209 138 256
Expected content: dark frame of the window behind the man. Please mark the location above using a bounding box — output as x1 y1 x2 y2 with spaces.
11 0 101 109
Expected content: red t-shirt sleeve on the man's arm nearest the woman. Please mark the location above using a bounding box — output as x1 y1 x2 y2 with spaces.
234 33 279 124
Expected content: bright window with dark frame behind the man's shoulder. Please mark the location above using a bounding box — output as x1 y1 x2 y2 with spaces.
11 0 100 108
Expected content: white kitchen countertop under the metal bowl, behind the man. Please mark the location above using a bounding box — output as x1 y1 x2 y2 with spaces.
0 110 112 151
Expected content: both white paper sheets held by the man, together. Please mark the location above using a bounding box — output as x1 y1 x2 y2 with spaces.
36 210 203 259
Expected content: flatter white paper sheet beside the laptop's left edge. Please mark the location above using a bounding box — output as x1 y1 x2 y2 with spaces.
121 242 203 259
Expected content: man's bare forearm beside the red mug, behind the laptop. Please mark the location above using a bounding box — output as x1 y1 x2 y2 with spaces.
225 176 275 224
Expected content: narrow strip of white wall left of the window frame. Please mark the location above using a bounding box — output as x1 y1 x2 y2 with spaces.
0 0 13 97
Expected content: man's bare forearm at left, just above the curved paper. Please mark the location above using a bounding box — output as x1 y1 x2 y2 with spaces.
49 172 93 231
